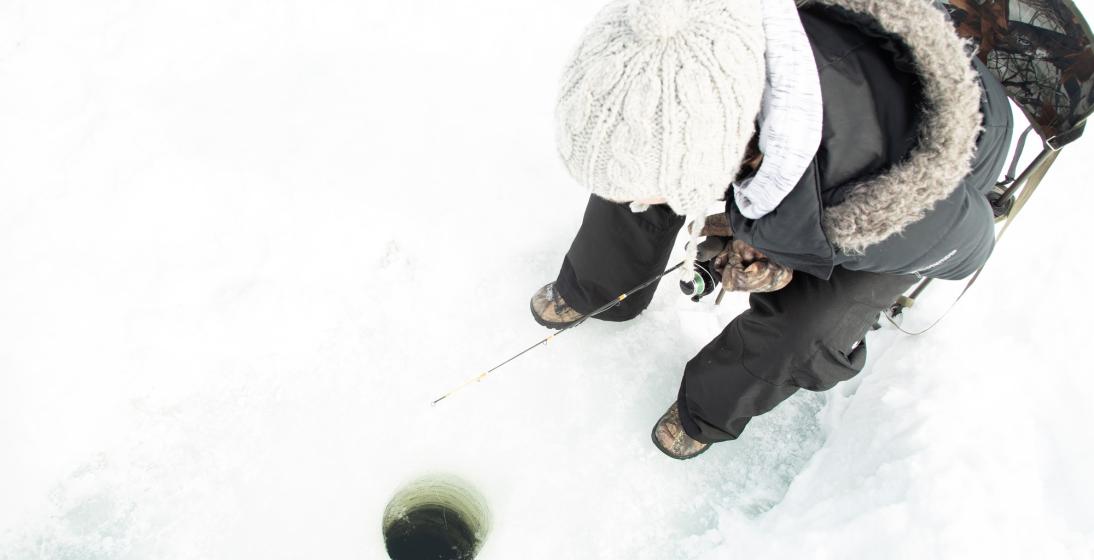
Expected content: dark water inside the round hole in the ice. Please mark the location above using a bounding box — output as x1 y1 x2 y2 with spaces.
384 505 477 560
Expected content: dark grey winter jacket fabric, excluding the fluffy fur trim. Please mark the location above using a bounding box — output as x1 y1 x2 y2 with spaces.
726 5 1013 279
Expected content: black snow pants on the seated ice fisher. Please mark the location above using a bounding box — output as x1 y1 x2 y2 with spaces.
556 197 916 443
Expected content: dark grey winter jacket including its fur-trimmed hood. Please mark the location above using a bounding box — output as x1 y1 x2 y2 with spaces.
725 0 1013 279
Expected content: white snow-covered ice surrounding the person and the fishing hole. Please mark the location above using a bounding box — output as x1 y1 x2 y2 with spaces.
0 0 1094 560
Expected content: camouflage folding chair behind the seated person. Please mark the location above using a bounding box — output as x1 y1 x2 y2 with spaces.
888 0 1094 319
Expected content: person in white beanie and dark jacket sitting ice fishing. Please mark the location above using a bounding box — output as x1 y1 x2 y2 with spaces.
532 0 1013 459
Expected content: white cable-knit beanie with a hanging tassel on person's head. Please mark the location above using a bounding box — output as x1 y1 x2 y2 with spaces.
557 0 765 276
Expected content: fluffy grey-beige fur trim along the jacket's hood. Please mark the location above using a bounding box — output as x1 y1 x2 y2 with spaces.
815 0 982 254
